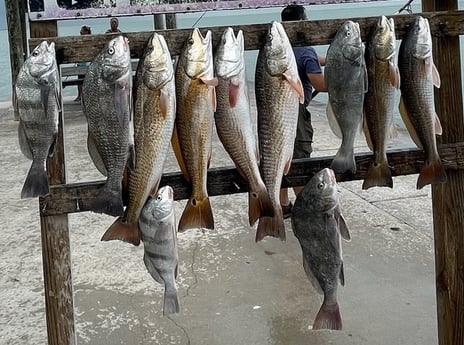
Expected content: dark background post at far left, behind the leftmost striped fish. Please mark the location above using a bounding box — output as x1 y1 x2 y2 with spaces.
5 0 26 120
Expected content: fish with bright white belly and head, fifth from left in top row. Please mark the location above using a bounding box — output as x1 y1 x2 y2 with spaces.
214 27 274 225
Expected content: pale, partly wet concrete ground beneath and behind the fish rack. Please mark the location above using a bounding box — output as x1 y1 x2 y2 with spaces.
0 94 437 345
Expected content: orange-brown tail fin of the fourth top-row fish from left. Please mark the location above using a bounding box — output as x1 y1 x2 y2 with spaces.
178 197 214 232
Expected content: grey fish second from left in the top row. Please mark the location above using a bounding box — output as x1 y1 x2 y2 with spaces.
82 36 134 216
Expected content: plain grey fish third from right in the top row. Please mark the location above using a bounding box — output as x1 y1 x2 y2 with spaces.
324 20 367 173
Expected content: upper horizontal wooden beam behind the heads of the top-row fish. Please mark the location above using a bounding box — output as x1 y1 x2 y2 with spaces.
29 11 464 63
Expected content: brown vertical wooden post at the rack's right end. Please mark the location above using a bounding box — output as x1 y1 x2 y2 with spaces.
422 0 464 345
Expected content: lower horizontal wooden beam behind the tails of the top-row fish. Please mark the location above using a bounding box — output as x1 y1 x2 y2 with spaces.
40 143 464 216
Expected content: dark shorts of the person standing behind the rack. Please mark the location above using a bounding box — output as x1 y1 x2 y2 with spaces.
293 104 313 159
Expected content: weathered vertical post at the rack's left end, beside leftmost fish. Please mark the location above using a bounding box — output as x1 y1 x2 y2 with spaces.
30 21 77 345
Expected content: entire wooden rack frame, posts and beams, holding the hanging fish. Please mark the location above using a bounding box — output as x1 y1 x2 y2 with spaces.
16 7 464 345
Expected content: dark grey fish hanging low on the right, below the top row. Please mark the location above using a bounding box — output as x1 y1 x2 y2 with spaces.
292 168 351 330
